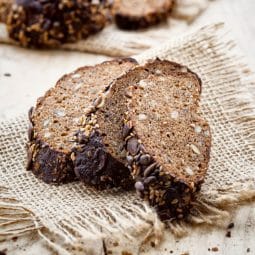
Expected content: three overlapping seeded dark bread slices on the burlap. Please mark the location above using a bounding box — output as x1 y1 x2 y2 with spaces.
27 58 211 220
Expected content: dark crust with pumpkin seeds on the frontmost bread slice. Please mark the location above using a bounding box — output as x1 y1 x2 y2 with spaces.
123 59 211 220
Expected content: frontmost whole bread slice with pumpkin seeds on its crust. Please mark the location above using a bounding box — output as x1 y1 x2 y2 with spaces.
123 60 211 220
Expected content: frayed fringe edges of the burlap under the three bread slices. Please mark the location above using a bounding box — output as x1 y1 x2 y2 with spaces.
0 24 255 254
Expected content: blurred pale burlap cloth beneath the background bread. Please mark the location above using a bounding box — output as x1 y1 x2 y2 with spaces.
0 0 209 57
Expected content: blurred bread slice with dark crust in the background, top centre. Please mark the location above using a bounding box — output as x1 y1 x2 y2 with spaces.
113 0 174 30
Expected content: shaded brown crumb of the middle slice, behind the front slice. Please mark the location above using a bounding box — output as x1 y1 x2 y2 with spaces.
97 60 201 172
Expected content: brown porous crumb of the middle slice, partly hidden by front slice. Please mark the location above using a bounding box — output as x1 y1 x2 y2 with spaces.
85 60 197 167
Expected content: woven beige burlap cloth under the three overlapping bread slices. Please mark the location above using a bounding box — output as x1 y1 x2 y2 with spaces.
0 24 255 254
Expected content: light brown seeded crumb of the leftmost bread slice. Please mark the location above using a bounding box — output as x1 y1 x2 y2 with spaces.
33 58 136 153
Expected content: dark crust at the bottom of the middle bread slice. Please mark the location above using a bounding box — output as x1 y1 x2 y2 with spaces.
74 131 134 189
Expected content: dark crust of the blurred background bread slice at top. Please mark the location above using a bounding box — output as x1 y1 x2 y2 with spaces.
114 0 174 30
